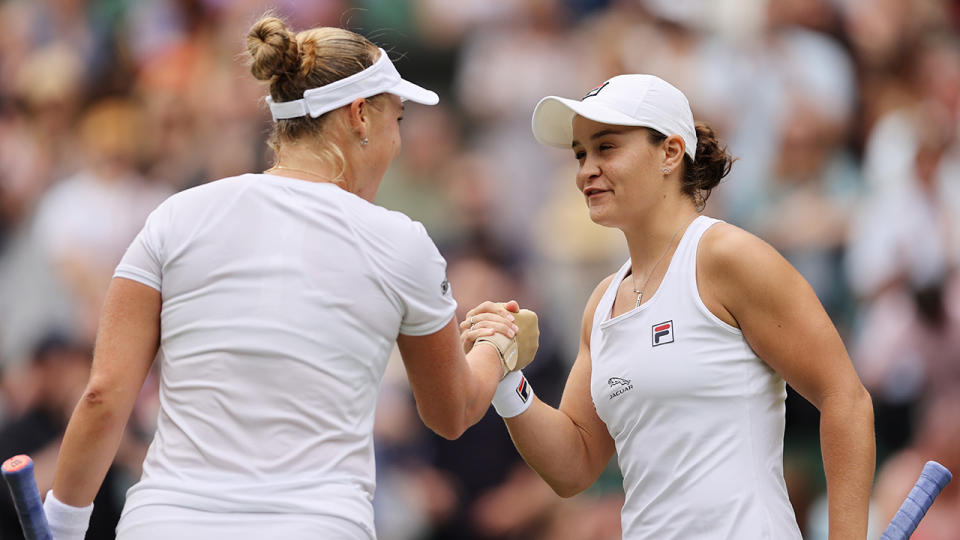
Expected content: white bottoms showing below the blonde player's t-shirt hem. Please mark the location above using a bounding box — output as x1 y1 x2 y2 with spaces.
117 504 376 540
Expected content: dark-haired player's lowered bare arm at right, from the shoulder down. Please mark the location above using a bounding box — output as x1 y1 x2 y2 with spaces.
697 224 876 540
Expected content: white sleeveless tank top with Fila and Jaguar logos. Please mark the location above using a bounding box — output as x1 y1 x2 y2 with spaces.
590 216 801 540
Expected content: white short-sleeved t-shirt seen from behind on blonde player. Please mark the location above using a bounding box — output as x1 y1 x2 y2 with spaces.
115 174 456 537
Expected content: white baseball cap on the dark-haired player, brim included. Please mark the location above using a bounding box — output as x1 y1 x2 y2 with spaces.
533 75 697 159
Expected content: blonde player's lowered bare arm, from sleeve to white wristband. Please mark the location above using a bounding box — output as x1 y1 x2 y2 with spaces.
53 278 161 507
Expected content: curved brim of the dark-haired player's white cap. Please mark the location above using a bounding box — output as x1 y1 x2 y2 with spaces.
532 96 643 148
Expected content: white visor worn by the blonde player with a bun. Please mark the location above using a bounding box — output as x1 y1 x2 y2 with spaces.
267 49 440 121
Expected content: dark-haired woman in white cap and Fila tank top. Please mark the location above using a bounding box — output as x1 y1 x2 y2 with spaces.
468 75 875 540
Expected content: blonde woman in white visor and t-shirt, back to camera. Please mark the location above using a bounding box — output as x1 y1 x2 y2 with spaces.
39 17 532 540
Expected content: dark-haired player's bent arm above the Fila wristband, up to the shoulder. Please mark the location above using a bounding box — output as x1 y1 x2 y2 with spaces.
504 276 616 497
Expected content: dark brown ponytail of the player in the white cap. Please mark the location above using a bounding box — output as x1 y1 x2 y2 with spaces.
648 122 736 211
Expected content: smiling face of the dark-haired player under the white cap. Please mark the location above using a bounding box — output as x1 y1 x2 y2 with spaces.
572 116 682 229
